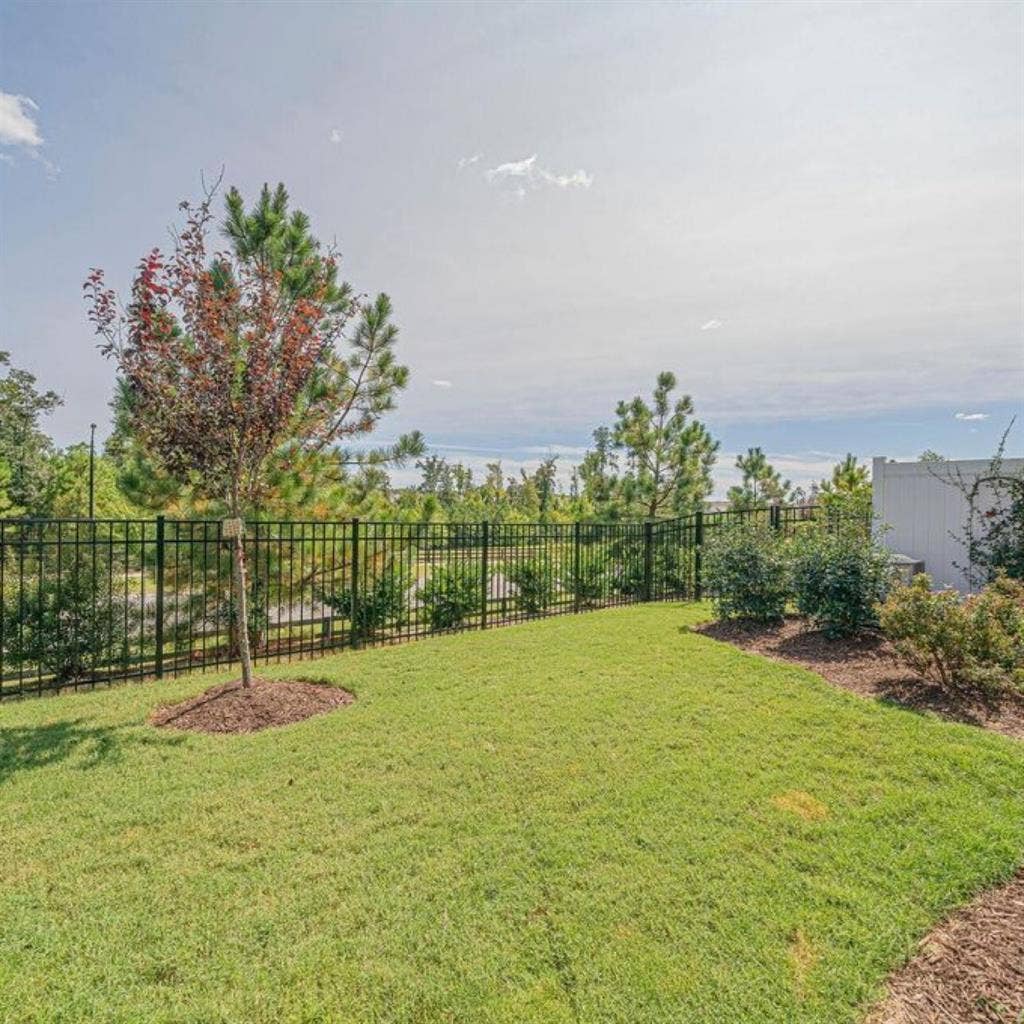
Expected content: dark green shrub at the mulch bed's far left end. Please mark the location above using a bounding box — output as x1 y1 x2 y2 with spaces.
702 522 792 623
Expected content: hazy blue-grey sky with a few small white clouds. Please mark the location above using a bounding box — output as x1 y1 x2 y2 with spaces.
0 2 1024 488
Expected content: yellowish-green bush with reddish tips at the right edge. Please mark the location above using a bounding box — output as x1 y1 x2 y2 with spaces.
879 573 1024 690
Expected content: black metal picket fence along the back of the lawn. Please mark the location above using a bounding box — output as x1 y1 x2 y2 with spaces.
0 508 839 698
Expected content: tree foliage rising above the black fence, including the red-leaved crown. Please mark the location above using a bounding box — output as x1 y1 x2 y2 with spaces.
0 178 870 522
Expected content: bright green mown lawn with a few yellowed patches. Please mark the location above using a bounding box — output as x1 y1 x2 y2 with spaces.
0 605 1024 1024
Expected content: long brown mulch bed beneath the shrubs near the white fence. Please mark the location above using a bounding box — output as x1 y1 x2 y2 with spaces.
697 618 1024 739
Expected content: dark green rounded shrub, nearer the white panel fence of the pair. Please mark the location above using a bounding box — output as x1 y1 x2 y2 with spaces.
793 525 892 637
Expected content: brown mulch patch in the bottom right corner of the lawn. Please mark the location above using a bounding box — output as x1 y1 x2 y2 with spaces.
867 871 1024 1024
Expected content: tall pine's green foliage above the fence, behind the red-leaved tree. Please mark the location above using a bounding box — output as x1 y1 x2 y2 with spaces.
105 184 424 518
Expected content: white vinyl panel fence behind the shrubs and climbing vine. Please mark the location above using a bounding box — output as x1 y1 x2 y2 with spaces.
871 458 1024 592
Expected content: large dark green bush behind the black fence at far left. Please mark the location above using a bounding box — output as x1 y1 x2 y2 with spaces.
3 552 141 683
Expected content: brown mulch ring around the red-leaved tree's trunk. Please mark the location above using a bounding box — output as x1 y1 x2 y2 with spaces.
150 679 355 732
